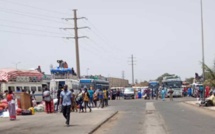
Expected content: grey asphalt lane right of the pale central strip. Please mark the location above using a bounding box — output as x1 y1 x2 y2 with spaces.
155 101 215 134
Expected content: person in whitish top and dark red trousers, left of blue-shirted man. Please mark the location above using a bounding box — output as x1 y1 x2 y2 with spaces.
43 87 52 114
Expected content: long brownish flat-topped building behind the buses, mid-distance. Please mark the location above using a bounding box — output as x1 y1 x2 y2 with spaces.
107 77 129 88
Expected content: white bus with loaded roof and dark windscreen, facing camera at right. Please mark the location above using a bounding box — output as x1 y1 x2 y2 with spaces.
162 75 183 97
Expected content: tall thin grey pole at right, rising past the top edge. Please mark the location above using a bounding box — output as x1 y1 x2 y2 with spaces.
200 0 205 101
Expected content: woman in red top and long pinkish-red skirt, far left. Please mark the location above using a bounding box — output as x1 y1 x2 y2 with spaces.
6 88 16 121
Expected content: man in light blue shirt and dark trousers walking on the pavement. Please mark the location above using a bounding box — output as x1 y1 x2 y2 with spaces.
60 85 72 127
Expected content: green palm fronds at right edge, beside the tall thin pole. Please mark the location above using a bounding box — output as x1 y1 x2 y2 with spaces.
204 64 215 87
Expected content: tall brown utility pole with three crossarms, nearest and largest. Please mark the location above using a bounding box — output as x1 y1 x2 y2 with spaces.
60 9 89 78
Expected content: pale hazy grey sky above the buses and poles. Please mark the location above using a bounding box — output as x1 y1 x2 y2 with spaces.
0 0 215 82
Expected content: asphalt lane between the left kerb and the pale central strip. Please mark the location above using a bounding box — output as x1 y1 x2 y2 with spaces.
94 99 145 134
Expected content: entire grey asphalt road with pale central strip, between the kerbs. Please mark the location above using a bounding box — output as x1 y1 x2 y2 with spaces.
94 98 215 134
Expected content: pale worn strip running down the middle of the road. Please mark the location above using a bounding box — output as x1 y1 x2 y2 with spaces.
144 102 167 134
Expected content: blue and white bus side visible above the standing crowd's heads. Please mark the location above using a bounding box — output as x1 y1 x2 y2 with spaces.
80 79 109 90
